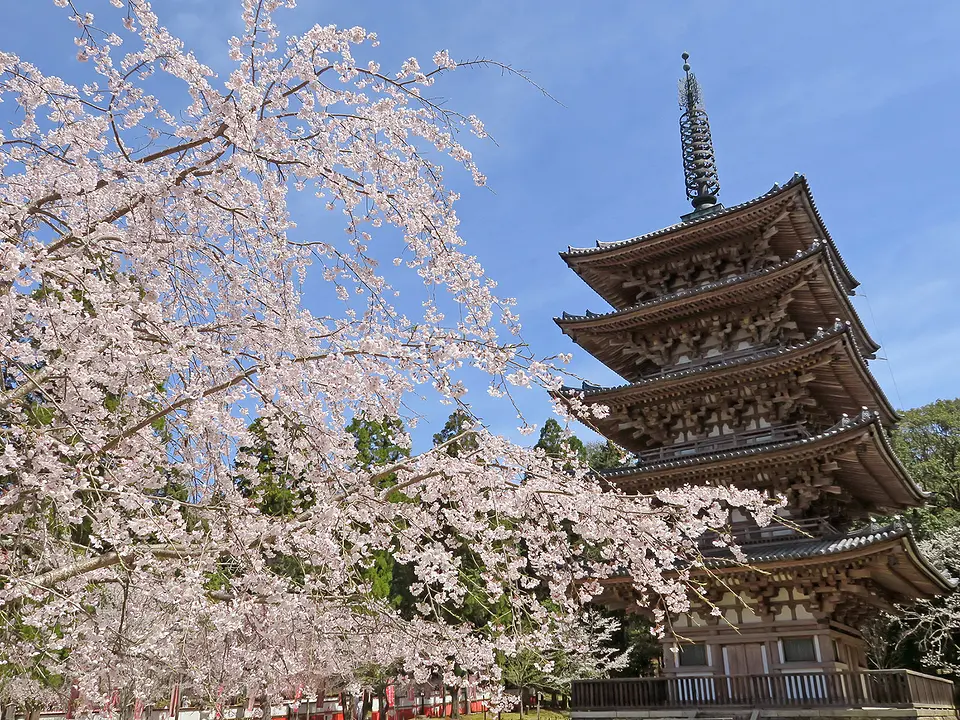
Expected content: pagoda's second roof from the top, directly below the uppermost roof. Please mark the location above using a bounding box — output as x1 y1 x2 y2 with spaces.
554 243 880 379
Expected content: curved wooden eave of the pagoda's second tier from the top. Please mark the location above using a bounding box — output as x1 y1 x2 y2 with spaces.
553 245 880 360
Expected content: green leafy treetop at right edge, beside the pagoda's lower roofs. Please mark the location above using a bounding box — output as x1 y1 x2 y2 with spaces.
892 398 960 537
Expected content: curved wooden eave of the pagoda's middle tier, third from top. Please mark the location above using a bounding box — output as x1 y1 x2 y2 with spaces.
555 324 899 425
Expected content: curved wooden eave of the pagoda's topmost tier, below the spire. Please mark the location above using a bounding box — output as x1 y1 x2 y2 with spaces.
560 175 860 292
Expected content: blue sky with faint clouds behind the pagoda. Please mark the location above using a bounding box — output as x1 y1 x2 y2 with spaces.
0 0 960 444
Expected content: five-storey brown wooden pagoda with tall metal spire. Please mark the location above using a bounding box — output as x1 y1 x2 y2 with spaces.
556 54 953 717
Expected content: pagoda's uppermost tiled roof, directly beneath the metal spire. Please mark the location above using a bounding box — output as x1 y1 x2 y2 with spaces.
560 174 859 306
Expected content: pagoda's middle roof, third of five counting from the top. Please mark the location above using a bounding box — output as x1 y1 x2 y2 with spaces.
559 322 899 436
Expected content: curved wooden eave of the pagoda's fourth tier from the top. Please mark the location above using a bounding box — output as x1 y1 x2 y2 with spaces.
601 413 930 510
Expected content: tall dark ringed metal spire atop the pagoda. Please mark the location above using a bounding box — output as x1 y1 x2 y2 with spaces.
679 53 720 211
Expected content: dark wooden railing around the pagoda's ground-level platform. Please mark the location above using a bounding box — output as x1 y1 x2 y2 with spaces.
570 670 954 712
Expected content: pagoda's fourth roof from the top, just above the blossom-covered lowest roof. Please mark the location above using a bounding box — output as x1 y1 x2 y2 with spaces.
600 411 930 511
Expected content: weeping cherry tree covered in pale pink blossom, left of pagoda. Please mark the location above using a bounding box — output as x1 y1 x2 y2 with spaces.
0 0 773 707
